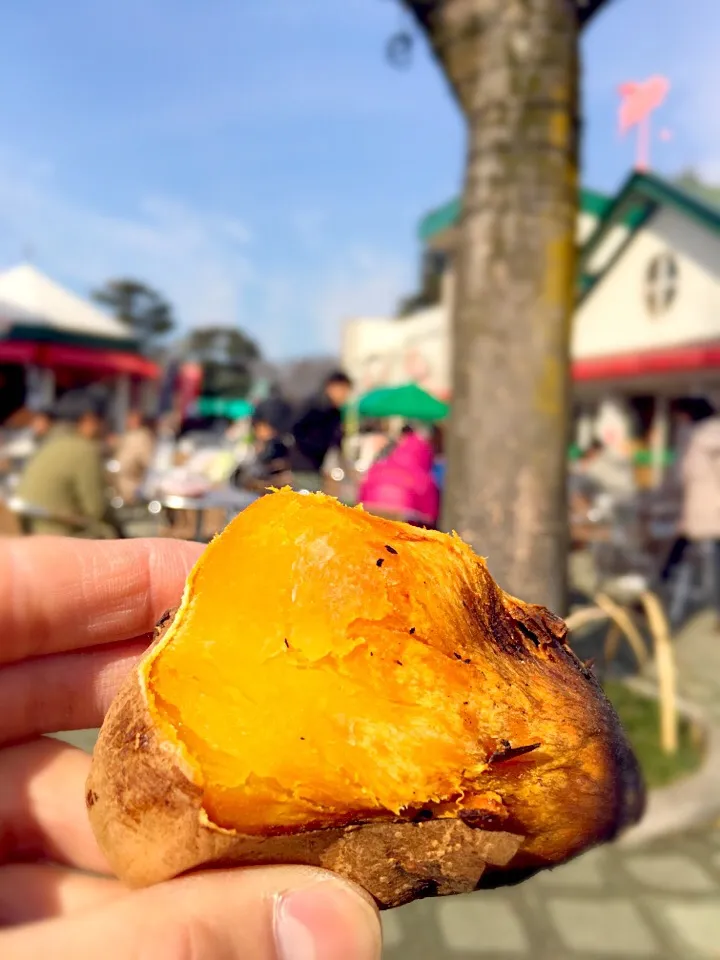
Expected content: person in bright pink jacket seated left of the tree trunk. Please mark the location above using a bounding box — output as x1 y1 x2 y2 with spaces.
359 429 440 526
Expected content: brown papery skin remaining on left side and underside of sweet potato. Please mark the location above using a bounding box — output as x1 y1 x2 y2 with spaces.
85 673 521 907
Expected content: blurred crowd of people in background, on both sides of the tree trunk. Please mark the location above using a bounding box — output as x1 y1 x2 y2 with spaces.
8 371 720 623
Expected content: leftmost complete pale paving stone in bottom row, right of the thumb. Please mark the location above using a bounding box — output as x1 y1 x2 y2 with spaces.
437 893 530 960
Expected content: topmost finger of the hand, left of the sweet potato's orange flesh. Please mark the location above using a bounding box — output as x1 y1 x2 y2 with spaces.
0 537 203 664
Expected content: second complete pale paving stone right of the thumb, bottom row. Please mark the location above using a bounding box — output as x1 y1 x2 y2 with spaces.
548 897 662 957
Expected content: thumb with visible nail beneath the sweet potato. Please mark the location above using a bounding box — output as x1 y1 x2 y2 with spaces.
0 867 381 960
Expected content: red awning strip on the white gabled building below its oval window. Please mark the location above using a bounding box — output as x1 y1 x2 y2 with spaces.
572 343 720 381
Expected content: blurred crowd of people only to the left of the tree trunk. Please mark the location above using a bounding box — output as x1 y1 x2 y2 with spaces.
1 371 450 537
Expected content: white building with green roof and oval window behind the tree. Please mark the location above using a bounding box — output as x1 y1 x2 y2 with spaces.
344 172 720 476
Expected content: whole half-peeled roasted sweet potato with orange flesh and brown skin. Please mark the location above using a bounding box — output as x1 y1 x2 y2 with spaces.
88 490 642 905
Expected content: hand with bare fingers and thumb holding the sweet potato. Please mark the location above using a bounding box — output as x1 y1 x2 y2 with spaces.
0 538 380 960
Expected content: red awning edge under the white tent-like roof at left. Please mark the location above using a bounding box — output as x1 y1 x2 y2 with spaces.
0 340 160 380
